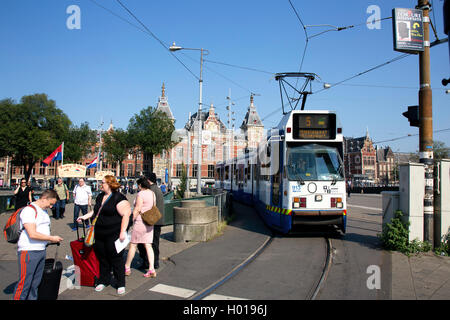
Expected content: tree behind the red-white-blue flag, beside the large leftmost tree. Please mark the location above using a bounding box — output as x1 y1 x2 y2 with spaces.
64 122 97 162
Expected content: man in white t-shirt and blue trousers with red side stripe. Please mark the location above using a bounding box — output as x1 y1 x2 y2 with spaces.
13 190 63 300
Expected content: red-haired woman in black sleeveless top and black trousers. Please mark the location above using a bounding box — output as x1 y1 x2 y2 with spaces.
77 175 131 294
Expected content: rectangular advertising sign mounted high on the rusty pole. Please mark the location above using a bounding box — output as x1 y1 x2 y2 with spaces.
392 8 424 53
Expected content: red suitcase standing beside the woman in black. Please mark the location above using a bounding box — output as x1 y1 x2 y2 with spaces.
70 224 100 287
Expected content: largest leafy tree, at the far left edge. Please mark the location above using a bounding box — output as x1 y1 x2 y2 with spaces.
0 93 71 179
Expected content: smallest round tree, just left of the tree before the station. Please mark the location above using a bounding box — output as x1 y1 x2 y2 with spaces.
102 128 132 175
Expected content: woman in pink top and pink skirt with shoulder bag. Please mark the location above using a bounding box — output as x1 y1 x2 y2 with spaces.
125 178 156 278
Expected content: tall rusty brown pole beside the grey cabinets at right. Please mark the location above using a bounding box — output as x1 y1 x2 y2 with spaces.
416 0 434 244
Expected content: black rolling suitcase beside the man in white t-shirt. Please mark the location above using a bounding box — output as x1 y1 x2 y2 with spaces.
38 243 63 300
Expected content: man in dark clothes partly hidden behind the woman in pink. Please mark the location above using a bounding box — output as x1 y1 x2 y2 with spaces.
138 172 164 269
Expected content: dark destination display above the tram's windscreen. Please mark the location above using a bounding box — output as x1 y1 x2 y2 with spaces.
292 113 336 140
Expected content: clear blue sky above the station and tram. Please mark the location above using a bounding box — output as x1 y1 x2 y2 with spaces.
0 0 450 152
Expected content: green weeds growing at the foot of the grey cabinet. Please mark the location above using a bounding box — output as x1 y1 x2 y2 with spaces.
380 210 431 256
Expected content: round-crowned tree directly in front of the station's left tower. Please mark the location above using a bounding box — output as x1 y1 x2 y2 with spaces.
128 106 177 172
